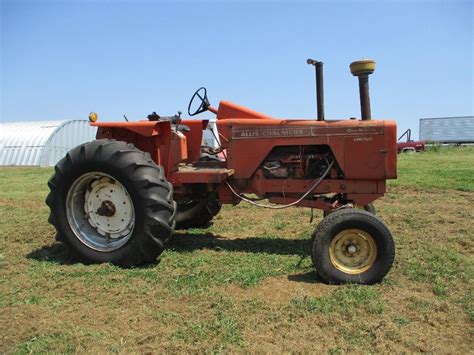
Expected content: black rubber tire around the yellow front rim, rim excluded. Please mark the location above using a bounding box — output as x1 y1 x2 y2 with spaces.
311 208 395 285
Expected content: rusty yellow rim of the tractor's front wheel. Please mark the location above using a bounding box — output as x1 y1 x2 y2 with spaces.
329 229 377 275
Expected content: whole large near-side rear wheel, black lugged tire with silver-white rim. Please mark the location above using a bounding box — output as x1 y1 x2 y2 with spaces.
46 140 176 267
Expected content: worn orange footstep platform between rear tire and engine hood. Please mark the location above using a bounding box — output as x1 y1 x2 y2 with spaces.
170 165 234 184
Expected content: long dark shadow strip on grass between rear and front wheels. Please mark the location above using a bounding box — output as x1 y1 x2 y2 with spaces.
168 232 311 256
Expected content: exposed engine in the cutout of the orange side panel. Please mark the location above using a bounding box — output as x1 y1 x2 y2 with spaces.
261 146 332 179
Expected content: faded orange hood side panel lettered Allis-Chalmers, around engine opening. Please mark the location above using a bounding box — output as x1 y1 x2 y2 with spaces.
217 119 397 180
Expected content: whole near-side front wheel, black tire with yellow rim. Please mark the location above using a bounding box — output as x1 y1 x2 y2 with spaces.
311 208 395 284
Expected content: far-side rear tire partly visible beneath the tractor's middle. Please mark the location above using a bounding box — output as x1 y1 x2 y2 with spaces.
176 194 222 229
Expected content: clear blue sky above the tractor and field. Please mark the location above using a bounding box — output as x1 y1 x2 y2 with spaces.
0 0 474 137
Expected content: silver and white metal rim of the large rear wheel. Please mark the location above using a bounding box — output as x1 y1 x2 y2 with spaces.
66 172 135 252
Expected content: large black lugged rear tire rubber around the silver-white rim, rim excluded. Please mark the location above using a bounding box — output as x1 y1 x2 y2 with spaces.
46 140 176 267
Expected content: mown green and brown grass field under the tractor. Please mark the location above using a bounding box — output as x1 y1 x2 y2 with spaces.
0 148 474 353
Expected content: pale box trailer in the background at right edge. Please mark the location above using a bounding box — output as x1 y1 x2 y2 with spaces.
420 116 474 144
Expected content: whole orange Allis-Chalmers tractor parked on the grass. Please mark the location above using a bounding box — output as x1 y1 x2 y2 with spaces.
46 59 397 284
